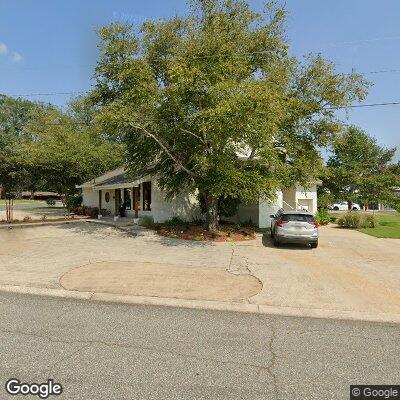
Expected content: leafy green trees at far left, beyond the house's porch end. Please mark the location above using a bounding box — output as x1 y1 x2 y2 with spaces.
0 96 123 219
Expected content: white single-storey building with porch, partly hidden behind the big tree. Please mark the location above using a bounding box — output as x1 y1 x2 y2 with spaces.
78 167 319 228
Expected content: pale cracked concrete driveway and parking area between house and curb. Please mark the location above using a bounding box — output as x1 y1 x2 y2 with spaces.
0 222 400 320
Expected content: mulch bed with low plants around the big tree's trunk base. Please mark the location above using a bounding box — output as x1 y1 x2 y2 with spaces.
153 224 255 242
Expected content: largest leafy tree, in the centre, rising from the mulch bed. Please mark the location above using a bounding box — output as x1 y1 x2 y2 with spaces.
91 0 368 230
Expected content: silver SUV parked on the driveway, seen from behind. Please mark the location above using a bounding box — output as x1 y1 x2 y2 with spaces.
270 211 318 249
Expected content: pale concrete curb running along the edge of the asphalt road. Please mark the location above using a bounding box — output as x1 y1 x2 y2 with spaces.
0 285 400 324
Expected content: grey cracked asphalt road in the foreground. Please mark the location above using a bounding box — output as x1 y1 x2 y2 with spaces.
0 294 400 400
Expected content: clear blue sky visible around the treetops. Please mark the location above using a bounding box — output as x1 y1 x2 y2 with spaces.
0 0 400 154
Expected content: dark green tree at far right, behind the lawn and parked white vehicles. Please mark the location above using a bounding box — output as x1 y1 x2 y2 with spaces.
322 126 399 210
